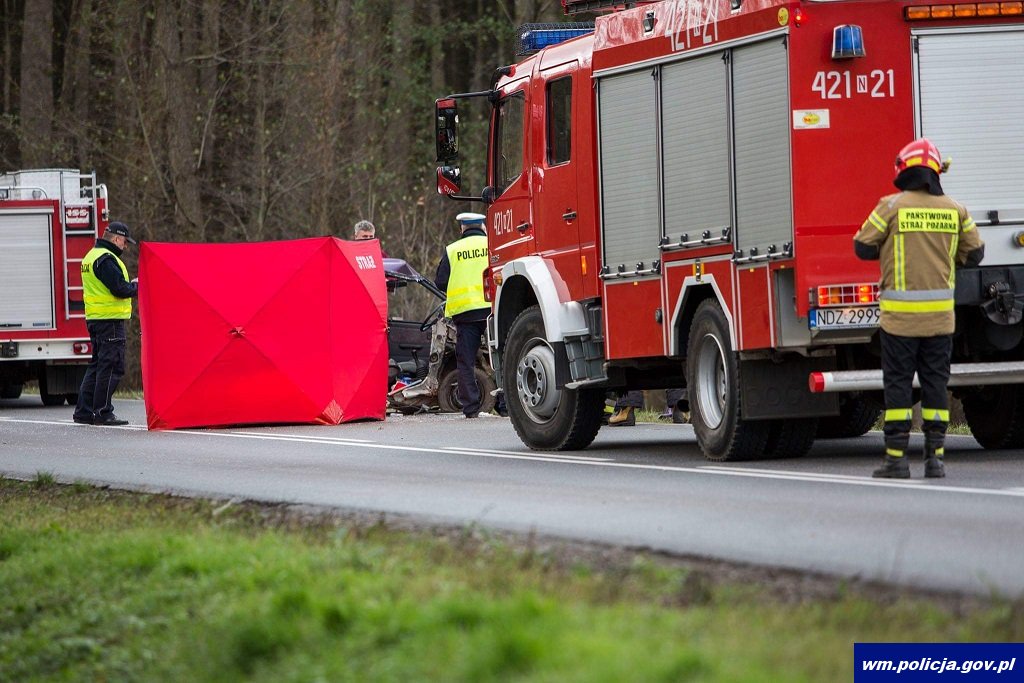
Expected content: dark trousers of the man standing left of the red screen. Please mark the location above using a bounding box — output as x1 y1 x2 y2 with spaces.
75 321 127 422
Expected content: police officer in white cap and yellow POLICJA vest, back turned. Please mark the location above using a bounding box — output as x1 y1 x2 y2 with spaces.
434 213 490 418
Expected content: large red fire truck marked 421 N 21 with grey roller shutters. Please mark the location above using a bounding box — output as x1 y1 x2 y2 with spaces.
435 0 1024 460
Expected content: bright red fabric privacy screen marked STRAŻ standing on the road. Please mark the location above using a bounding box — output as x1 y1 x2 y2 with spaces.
139 238 388 429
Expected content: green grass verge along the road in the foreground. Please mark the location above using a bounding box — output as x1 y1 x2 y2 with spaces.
0 475 1024 682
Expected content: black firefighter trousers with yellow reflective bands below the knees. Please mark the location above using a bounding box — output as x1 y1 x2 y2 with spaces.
880 330 952 458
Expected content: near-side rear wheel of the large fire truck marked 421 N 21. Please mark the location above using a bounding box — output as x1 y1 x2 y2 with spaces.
686 299 771 462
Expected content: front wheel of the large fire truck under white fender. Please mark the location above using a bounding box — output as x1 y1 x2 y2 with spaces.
502 306 604 451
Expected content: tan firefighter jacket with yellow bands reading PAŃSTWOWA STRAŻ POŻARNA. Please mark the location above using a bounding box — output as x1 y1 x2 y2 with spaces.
854 190 984 337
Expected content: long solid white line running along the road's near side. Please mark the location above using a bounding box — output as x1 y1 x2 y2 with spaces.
0 418 1024 498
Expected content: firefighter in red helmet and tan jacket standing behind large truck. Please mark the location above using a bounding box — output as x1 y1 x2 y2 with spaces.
853 138 985 479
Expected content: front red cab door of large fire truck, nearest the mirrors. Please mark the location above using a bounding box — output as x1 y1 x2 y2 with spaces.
487 79 535 267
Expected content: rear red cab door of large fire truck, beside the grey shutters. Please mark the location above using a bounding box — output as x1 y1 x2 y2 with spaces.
534 61 581 298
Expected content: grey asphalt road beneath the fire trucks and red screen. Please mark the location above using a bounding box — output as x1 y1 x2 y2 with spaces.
0 396 1024 596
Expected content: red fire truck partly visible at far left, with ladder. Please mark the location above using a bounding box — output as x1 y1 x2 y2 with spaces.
0 169 108 405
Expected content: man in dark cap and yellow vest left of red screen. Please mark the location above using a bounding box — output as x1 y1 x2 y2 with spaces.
74 221 138 426
